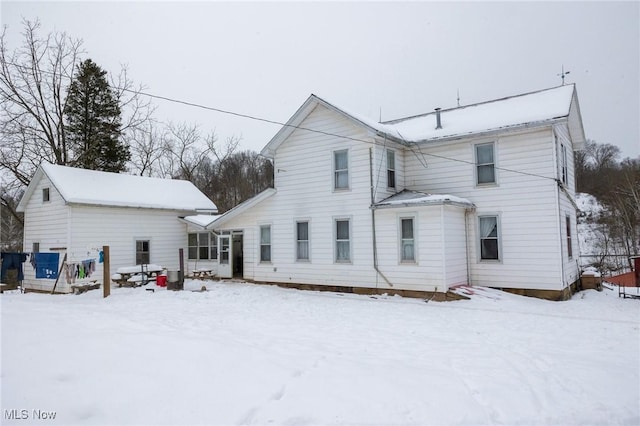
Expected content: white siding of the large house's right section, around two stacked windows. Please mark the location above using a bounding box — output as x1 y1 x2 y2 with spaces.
405 128 563 290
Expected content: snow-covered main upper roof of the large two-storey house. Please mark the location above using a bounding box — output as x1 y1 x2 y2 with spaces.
262 84 585 158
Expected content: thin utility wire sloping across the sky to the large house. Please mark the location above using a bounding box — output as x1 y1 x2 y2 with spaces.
6 58 557 182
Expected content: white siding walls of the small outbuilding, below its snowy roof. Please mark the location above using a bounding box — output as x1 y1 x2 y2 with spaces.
25 194 192 292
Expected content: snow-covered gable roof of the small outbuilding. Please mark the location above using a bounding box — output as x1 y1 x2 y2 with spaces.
18 163 218 212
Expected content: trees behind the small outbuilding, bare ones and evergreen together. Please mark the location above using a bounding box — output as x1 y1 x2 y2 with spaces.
0 20 273 251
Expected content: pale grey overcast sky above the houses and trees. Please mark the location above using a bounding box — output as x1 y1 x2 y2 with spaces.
0 1 640 157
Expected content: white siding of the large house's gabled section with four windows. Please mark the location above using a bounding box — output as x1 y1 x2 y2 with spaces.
222 106 386 287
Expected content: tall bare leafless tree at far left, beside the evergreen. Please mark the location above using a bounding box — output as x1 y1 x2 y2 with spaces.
0 21 82 185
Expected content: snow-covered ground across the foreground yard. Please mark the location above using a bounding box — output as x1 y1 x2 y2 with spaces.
0 281 640 425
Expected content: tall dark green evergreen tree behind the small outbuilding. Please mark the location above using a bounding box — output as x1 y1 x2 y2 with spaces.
64 59 131 172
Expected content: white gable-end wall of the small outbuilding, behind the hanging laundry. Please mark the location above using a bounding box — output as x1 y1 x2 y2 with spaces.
23 175 69 291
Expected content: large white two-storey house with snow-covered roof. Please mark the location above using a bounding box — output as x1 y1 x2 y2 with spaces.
200 85 585 299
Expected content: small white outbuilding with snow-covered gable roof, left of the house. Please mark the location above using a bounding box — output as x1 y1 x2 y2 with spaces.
18 164 217 292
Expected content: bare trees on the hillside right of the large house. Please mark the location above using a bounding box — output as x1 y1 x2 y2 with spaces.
575 140 640 272
